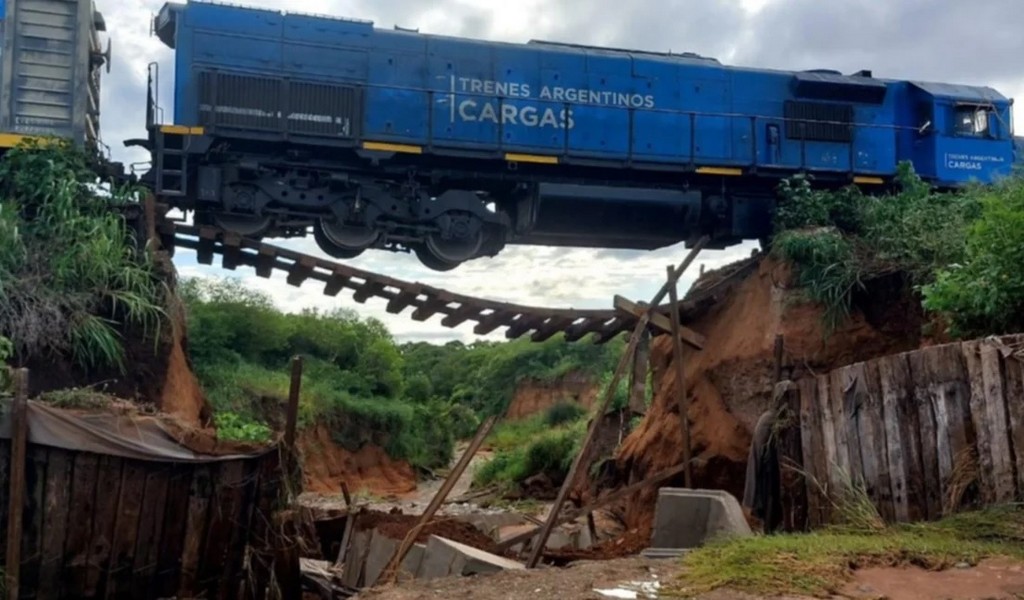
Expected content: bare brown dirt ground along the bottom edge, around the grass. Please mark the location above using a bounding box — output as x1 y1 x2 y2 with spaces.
355 558 1024 600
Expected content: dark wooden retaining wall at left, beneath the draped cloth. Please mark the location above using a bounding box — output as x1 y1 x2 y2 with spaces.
0 439 281 599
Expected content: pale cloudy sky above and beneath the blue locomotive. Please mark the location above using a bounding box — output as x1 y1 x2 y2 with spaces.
96 0 1024 341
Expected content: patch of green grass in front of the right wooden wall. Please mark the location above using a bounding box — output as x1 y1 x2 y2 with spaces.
671 505 1024 597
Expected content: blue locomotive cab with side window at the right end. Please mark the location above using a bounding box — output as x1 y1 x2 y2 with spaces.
911 83 1016 187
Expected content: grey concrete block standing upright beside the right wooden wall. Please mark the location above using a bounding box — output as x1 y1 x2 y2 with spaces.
650 487 753 549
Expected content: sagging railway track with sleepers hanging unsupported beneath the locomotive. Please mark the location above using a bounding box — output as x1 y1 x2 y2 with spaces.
158 219 758 344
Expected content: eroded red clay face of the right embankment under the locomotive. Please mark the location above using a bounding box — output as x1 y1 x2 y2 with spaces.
608 258 921 537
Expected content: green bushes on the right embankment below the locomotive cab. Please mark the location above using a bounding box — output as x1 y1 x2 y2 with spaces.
772 164 1024 337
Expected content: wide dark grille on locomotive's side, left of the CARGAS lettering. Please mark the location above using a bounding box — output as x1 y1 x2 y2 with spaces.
199 71 360 138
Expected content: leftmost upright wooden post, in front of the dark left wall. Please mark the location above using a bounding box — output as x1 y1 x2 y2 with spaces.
7 369 29 600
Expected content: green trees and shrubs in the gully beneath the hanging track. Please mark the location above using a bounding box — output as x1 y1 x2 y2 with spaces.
179 280 616 469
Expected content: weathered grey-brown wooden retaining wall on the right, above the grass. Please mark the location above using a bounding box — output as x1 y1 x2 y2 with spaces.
783 336 1024 526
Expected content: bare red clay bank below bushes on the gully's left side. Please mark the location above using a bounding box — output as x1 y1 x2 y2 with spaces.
298 425 416 497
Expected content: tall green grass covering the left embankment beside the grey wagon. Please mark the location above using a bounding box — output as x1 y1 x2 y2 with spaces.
0 140 168 373
